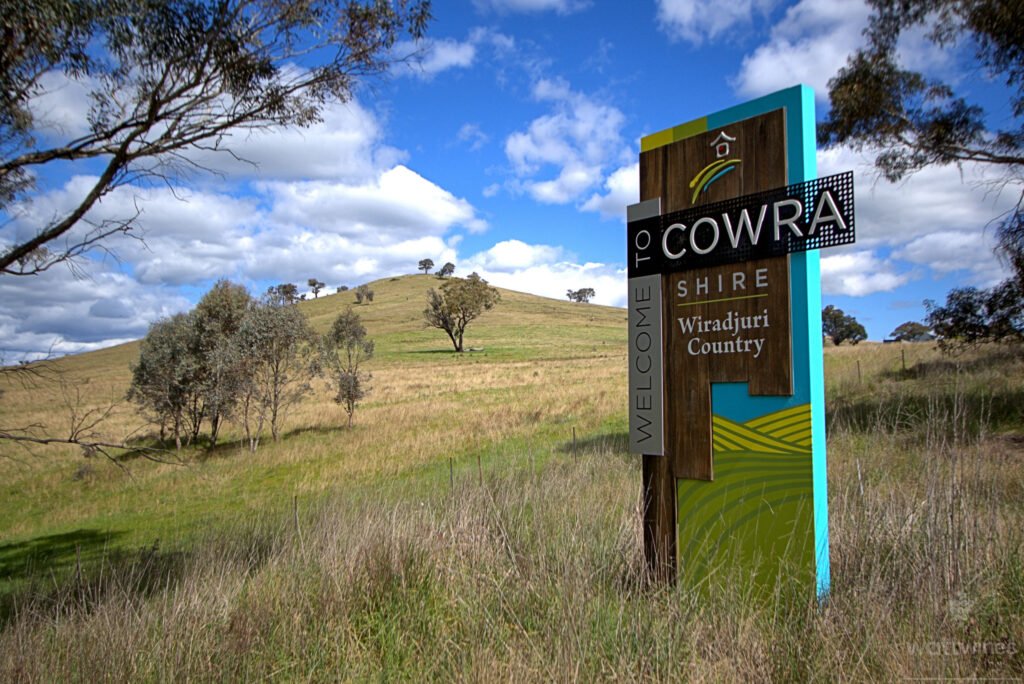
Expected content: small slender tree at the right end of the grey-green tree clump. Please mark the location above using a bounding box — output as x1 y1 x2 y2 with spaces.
322 308 374 427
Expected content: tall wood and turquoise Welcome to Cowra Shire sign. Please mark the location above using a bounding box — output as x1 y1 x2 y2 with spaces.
628 86 855 593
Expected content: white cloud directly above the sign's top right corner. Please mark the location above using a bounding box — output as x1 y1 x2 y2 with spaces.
734 0 868 99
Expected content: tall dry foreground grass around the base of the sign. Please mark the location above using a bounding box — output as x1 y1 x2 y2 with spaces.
0 358 1024 682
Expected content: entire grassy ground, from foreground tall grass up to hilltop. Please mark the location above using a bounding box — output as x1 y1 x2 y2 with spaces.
0 275 1024 682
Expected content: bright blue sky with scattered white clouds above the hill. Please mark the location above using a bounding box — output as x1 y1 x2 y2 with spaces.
0 0 1015 362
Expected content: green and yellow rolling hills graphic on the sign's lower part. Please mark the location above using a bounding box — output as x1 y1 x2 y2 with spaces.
678 403 814 587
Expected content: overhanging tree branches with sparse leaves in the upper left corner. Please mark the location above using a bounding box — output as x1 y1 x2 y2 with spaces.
0 0 430 275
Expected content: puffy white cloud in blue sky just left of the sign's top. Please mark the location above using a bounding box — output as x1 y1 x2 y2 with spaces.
505 79 631 204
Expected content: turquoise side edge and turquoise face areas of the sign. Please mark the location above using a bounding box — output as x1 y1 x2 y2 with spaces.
692 85 831 597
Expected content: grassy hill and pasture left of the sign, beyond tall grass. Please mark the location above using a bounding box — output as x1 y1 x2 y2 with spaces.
0 275 626 557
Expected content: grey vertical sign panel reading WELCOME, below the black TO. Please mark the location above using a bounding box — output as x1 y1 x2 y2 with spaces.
629 275 665 456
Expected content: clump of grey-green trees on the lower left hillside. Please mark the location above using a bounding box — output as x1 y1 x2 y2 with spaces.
128 281 373 452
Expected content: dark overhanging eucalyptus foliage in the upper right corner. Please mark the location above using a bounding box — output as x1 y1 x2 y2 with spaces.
818 0 1024 282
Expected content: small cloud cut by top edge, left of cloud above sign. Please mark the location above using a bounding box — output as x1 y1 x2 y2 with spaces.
657 0 774 45
